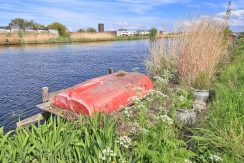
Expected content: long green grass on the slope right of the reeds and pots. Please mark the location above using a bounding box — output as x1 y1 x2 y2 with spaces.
192 41 244 162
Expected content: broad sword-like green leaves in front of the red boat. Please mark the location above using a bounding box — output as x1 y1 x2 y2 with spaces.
0 115 133 163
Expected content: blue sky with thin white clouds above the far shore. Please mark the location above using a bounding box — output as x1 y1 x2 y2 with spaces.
0 0 244 31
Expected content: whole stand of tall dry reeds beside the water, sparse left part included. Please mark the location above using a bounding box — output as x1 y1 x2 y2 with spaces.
147 17 228 85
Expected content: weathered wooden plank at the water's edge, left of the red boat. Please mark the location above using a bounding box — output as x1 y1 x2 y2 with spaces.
16 111 50 127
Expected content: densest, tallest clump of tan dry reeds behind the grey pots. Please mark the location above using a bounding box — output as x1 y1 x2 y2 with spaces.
177 18 228 84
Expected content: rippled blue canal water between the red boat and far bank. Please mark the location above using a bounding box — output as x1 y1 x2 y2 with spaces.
0 40 148 130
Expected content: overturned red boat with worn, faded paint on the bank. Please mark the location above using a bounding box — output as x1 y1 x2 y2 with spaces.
52 72 153 115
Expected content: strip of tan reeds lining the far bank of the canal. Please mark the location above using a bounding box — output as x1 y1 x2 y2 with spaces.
0 32 179 47
